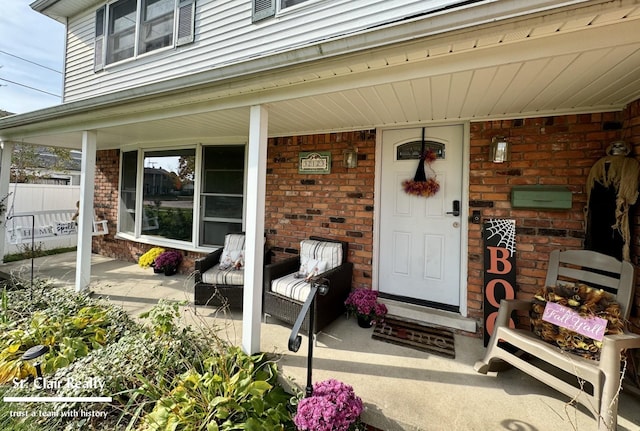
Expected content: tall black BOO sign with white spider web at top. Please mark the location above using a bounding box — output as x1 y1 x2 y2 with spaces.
482 219 516 347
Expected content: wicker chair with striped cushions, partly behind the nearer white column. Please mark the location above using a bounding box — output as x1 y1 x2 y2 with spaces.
194 233 271 309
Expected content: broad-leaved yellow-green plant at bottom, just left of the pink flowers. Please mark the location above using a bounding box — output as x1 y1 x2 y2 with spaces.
138 347 295 431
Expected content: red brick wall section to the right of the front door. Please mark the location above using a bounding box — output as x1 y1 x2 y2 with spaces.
468 108 640 330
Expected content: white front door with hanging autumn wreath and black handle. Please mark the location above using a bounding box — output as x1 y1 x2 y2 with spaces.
378 125 464 311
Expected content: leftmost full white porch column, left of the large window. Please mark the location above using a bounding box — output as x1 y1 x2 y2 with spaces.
75 131 97 292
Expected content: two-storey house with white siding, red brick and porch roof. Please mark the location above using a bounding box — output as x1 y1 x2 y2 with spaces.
0 0 640 354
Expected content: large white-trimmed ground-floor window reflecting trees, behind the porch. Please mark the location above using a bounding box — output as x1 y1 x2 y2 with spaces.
118 145 245 247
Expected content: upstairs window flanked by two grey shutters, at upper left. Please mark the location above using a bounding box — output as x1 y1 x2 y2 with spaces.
94 0 195 70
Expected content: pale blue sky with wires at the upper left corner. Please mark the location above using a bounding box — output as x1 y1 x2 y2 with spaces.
0 0 65 114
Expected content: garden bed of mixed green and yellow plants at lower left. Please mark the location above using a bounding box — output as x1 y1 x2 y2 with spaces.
0 288 298 431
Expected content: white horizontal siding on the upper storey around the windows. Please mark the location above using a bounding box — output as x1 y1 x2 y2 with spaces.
65 0 476 102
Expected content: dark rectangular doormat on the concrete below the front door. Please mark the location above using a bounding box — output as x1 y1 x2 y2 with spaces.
371 317 456 359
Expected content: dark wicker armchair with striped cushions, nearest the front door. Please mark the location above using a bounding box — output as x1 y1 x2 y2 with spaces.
262 236 353 335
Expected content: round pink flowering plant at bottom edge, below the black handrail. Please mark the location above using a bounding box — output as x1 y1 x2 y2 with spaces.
293 379 365 431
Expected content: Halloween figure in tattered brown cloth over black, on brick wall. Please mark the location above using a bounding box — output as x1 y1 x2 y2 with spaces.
585 141 640 261
